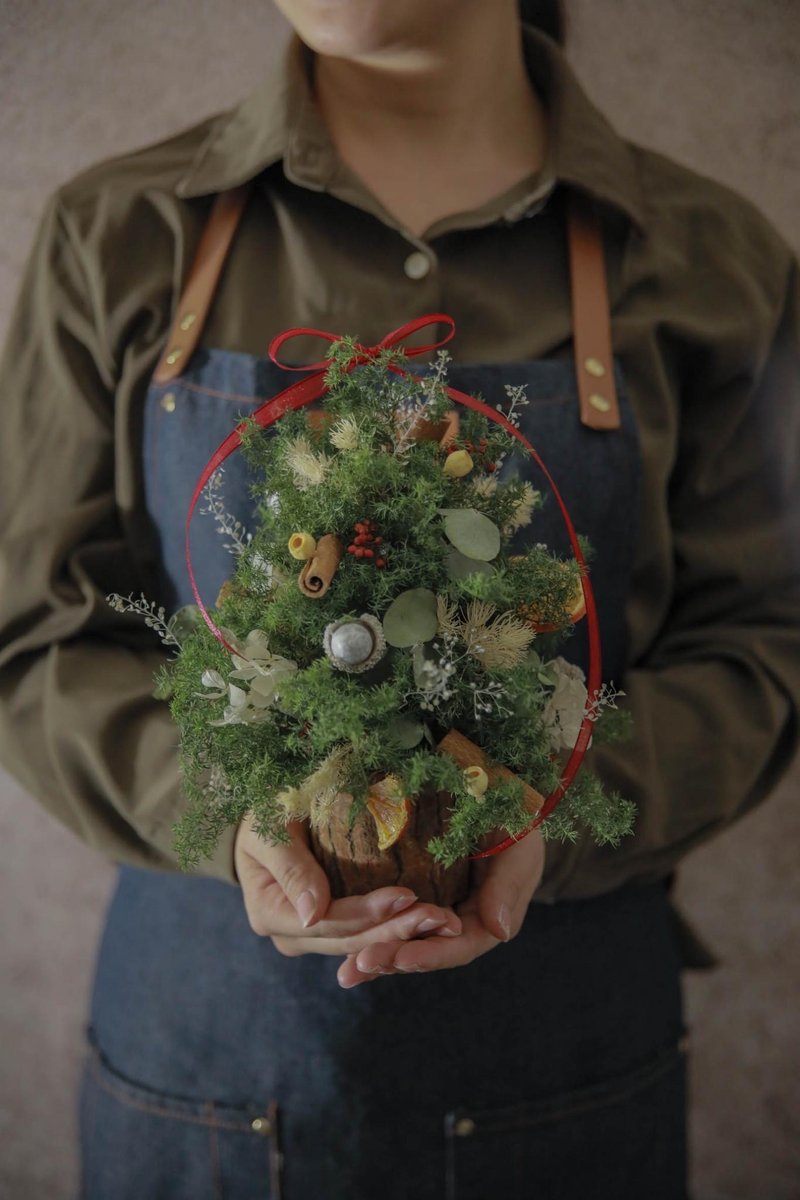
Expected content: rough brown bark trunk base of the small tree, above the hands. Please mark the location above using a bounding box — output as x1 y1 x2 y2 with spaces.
309 790 469 906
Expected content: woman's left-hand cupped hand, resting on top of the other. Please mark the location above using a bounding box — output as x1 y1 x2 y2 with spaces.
234 815 462 956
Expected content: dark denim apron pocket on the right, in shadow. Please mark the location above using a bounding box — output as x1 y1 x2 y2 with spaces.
445 1037 688 1200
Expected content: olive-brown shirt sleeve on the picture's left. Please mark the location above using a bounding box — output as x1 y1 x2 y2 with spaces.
0 192 237 883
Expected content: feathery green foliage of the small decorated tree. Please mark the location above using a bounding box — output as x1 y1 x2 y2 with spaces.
117 338 633 870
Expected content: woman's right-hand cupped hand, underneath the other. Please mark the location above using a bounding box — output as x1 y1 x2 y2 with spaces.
337 829 545 988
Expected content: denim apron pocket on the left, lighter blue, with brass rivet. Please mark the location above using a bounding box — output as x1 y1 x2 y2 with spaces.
79 1028 283 1200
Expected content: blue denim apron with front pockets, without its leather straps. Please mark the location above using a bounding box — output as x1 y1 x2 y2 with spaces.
80 229 686 1200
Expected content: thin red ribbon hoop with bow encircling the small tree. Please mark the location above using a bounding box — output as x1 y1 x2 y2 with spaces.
185 312 602 859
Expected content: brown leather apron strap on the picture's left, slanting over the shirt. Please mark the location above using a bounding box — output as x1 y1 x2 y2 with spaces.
152 180 252 383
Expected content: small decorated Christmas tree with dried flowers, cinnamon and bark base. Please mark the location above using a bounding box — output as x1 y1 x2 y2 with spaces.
109 324 633 904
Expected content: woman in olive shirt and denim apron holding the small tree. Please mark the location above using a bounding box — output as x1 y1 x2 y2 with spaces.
0 0 800 1200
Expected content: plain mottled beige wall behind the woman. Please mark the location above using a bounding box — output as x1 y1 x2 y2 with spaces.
0 0 800 1200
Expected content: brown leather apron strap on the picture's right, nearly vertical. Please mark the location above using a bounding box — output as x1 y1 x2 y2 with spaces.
567 191 620 430
